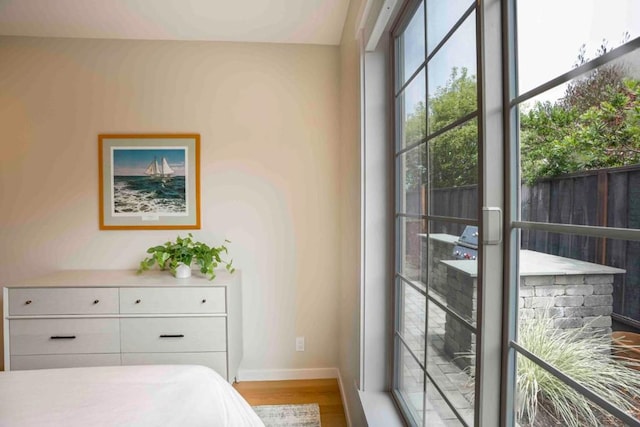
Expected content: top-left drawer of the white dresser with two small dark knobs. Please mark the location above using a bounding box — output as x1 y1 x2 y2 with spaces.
9 288 118 316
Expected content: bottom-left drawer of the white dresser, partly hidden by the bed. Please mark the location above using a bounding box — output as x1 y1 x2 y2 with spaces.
11 353 120 371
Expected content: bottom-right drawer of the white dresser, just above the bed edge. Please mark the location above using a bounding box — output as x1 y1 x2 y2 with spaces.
122 351 228 379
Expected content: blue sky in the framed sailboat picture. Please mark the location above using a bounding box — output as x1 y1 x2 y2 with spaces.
113 147 186 176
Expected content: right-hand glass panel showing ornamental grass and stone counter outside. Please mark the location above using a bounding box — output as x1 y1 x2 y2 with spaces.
505 0 640 426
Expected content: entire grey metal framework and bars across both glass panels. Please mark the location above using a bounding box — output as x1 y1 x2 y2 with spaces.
389 0 640 426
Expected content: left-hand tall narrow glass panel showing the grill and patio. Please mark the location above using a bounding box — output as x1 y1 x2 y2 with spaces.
393 0 482 426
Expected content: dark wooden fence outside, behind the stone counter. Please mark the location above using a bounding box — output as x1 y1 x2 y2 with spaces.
411 165 640 322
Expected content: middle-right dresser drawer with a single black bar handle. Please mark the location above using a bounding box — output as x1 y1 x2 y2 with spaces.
120 317 227 353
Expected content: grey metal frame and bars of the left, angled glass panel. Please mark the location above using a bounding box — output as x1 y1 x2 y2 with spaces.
389 0 488 425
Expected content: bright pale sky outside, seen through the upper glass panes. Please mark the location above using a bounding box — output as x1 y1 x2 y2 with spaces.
404 0 640 114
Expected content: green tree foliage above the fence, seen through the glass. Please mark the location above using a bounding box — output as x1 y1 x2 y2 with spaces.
403 37 640 190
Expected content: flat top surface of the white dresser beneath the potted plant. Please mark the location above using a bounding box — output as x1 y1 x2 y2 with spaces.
2 270 240 288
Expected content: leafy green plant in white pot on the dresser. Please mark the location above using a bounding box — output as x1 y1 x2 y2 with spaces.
138 233 235 280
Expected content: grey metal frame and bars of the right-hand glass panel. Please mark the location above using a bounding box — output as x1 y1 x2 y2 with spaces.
501 0 640 426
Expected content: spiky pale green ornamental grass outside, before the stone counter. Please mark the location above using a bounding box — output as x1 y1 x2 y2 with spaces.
517 318 640 427
